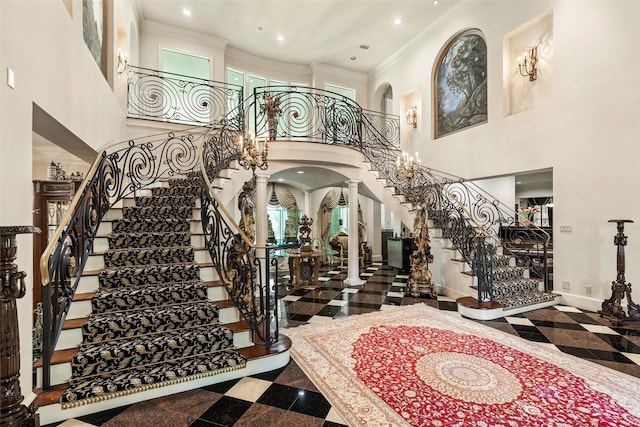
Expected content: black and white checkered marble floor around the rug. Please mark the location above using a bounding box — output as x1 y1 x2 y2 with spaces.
47 264 640 427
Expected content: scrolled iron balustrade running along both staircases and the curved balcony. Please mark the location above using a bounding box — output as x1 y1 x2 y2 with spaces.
40 79 549 394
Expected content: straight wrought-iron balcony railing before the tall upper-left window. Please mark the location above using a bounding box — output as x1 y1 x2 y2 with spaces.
127 66 244 125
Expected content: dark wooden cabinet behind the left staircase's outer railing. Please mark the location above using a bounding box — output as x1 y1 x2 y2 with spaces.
33 181 78 308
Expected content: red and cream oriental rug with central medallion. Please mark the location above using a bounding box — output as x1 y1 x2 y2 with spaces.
283 304 640 427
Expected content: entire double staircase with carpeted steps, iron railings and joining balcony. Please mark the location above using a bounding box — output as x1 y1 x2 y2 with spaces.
36 83 557 423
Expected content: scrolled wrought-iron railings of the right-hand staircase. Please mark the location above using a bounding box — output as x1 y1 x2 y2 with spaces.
352 112 551 302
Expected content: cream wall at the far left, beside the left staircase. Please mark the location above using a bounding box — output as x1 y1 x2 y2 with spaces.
0 0 134 402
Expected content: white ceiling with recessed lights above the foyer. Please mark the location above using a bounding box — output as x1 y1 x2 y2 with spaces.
137 0 459 73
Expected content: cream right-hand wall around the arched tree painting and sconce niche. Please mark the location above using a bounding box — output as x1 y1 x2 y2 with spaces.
369 0 640 310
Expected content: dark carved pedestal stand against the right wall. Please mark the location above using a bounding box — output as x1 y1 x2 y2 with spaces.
598 219 640 324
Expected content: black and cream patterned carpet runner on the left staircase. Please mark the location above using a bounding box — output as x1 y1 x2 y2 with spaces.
60 177 246 408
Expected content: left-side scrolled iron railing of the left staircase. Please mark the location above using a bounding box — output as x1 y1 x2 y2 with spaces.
40 127 209 390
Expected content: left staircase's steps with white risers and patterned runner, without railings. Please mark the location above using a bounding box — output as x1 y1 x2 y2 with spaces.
32 176 288 422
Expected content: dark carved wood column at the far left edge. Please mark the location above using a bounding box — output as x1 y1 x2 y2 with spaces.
0 226 40 427
